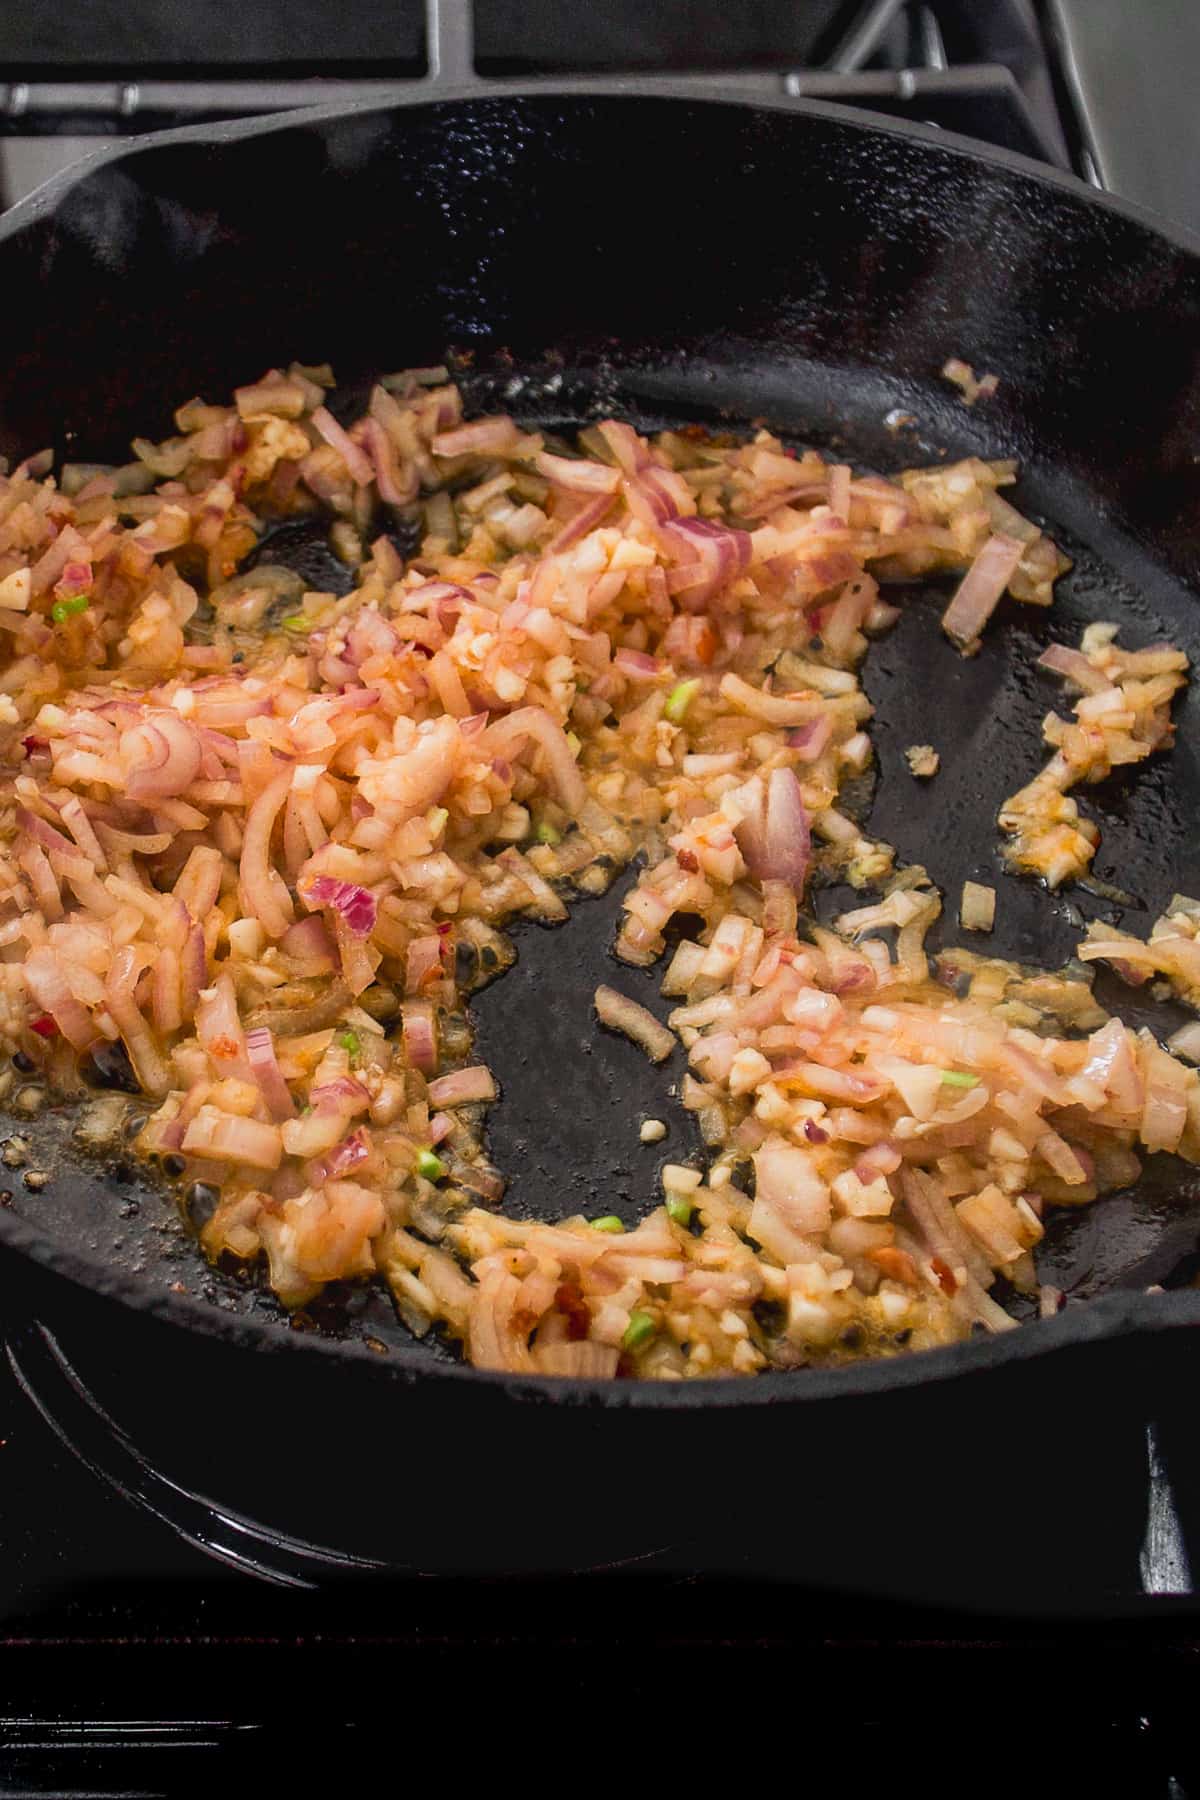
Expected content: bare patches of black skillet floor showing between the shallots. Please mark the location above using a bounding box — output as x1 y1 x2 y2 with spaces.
9 390 1200 1355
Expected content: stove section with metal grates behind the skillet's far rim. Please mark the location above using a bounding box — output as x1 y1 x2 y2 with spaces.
0 0 1200 229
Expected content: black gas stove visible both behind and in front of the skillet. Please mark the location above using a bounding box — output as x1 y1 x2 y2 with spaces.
0 0 1200 1796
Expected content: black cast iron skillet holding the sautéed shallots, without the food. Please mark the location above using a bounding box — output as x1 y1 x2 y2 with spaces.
0 83 1200 1566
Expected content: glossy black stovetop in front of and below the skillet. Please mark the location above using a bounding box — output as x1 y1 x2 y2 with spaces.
0 1224 1200 1800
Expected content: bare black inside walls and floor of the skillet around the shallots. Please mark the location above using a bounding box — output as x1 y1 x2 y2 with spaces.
0 95 1200 1388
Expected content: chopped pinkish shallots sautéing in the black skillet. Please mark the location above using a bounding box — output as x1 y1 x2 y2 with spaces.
0 364 1180 1381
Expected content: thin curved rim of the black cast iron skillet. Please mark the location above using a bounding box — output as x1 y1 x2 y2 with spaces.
0 77 1200 1413
